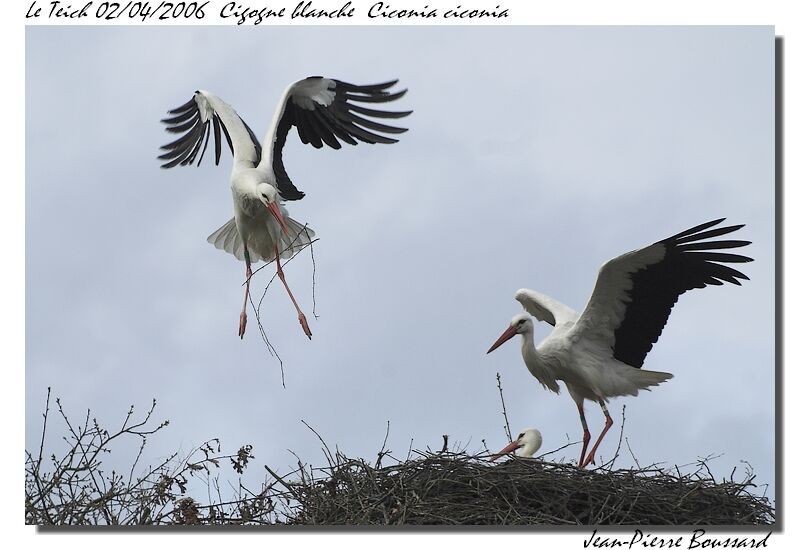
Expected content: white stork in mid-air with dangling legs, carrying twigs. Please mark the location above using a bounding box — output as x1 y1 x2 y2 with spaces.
158 76 411 339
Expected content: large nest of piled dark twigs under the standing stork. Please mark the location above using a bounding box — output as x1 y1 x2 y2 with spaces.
270 452 775 526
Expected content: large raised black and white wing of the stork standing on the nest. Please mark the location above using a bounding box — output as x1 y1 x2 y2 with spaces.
573 218 753 368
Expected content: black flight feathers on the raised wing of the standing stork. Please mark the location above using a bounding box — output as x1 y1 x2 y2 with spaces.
614 218 753 368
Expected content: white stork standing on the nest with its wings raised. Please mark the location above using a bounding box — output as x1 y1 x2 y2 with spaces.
487 218 753 468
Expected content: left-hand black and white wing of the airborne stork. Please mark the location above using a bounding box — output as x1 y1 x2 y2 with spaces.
158 90 261 168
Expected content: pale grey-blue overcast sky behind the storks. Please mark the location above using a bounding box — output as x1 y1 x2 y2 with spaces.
25 27 775 508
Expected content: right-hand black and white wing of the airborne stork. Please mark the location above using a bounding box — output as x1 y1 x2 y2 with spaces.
261 76 411 200
